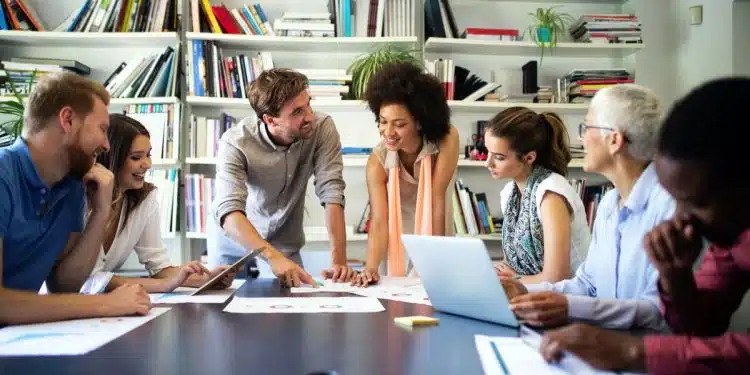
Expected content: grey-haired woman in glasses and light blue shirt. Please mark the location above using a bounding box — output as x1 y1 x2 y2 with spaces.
502 84 675 330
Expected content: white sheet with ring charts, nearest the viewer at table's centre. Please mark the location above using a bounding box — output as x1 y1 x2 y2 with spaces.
224 297 385 314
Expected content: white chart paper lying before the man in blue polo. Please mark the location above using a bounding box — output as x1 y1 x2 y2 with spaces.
0 307 169 356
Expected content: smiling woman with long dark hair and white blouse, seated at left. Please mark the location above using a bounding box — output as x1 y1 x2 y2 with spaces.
83 114 234 293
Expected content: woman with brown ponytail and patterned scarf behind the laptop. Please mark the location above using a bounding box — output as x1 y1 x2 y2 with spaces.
485 107 591 284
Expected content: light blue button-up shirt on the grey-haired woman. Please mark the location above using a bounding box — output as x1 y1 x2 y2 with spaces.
526 164 675 330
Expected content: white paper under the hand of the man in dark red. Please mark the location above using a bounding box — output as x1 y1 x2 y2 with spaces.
474 330 613 375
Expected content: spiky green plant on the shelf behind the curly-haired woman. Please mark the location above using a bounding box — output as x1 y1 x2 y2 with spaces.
347 45 422 100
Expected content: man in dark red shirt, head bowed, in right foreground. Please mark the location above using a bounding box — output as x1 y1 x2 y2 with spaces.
542 78 750 375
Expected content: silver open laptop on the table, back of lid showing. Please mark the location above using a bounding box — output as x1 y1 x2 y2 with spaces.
401 234 520 327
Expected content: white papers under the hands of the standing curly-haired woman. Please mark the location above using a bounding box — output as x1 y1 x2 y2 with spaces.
292 276 431 305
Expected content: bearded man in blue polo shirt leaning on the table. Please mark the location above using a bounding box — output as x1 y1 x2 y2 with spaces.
0 72 150 325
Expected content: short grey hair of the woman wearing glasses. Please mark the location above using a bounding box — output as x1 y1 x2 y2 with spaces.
591 83 664 161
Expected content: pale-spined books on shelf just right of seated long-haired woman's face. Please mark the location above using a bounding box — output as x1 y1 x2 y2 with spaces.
146 168 180 237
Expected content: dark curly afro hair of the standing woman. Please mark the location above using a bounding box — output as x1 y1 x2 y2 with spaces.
365 62 450 143
